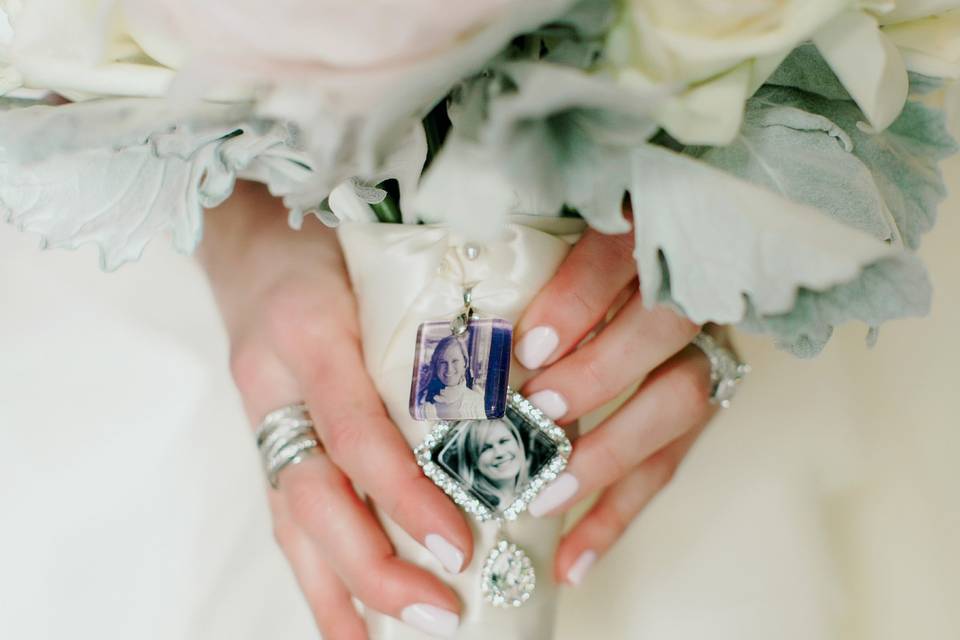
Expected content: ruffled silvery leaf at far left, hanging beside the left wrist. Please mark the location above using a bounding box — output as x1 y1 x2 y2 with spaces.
0 99 309 270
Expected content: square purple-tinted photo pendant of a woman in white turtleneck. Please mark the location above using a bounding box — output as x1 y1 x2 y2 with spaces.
410 318 513 420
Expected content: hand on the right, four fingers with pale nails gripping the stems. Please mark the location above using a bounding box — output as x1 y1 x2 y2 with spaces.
516 231 715 584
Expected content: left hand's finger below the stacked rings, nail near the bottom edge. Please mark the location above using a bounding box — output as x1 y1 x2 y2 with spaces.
280 454 460 636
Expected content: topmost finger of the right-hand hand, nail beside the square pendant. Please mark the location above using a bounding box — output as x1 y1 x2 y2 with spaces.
515 230 637 369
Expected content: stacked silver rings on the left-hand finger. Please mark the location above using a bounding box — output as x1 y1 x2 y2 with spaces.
256 403 320 489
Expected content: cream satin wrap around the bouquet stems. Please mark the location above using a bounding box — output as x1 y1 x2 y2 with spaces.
338 216 584 640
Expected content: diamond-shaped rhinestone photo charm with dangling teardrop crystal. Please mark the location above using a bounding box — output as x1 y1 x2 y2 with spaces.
414 389 572 607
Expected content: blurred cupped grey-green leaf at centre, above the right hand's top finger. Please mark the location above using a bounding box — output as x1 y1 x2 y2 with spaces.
483 63 661 233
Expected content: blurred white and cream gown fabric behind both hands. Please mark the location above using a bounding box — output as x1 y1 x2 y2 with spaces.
0 156 960 640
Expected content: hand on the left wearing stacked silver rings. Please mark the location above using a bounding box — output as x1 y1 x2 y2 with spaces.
199 183 473 639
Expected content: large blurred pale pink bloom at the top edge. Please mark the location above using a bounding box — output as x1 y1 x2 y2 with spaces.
124 0 543 71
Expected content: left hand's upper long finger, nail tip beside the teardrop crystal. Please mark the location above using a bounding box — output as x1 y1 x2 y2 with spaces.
276 335 473 573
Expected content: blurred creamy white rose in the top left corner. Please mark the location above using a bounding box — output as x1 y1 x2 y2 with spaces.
0 0 173 100
